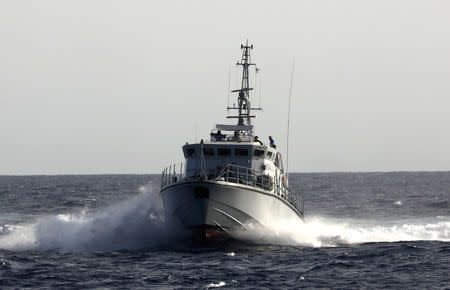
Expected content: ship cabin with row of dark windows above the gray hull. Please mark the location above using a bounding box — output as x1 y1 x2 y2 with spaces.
183 125 287 191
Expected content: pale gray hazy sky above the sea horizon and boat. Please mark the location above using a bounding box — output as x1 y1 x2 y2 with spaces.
0 0 450 174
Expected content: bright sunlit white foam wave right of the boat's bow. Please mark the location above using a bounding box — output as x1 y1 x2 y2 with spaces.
234 217 450 247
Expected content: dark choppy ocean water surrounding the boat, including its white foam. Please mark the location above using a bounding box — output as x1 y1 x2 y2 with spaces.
0 172 450 289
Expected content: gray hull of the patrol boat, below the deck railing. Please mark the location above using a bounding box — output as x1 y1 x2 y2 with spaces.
161 181 303 231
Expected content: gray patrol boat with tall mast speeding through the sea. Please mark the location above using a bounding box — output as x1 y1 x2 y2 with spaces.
161 43 304 241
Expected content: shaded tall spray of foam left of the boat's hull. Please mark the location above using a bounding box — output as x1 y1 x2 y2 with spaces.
0 185 173 251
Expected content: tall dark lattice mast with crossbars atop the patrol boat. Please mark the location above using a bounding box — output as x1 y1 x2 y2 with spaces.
227 41 261 130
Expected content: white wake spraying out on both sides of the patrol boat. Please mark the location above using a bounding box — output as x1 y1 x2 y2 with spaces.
0 185 450 251
